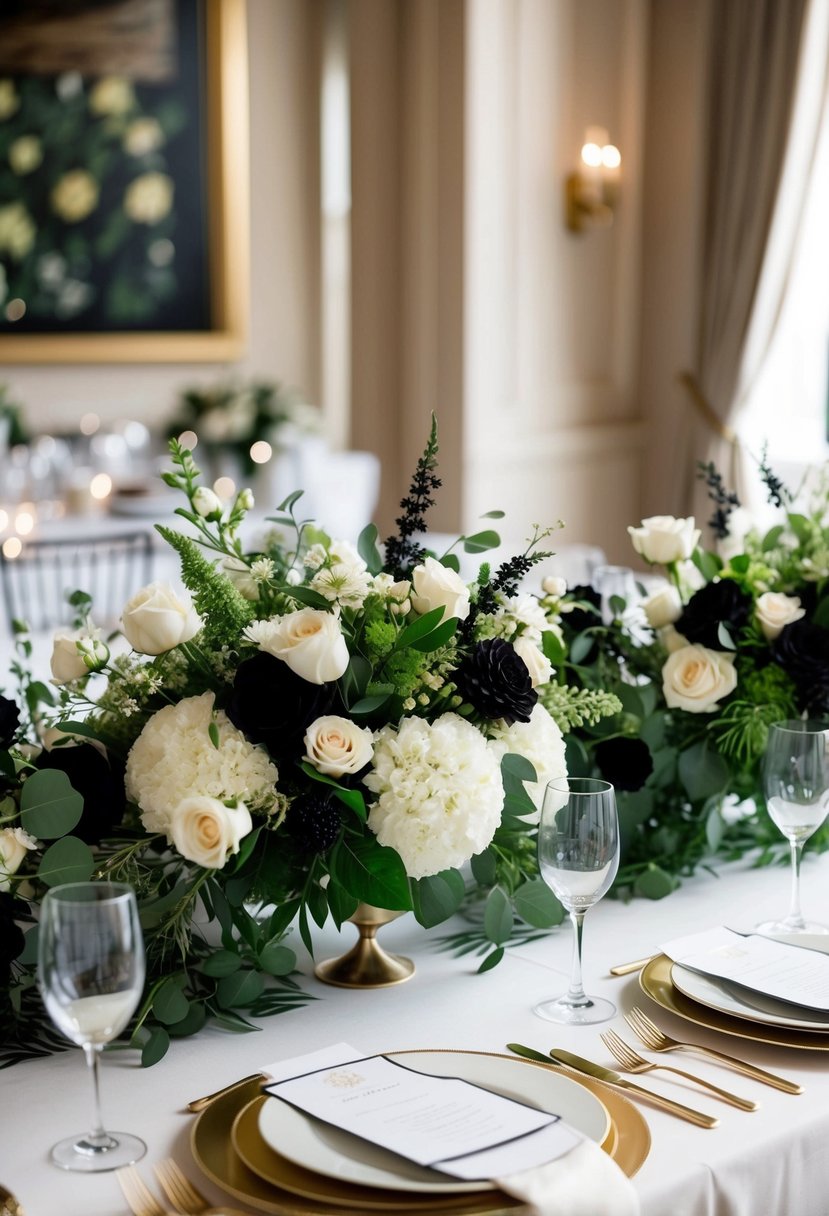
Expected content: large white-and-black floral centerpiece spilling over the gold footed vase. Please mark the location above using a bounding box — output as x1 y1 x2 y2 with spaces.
0 424 619 1063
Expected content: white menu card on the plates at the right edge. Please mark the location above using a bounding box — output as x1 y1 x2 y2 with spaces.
660 925 829 1014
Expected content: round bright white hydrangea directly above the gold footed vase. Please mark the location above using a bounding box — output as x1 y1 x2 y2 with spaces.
363 714 503 878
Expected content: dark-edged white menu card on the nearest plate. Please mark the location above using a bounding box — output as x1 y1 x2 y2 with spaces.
264 1043 582 1180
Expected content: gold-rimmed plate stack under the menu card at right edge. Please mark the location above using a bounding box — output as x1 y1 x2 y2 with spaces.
639 955 829 1052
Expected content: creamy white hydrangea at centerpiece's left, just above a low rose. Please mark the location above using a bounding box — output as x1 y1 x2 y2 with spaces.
126 692 278 839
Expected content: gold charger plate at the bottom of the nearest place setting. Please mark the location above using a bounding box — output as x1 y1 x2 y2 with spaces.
190 1052 650 1216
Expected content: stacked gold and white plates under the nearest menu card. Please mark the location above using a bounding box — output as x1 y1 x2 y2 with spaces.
191 1051 650 1216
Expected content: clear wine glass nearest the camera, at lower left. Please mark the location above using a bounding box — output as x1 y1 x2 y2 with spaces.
38 883 147 1173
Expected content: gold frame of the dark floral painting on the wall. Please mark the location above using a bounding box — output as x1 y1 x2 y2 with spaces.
0 0 249 365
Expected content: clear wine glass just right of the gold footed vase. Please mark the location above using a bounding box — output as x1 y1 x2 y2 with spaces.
532 777 619 1026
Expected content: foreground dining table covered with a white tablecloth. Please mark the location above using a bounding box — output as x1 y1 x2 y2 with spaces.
0 851 829 1216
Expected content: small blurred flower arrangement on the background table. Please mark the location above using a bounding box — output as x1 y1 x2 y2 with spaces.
167 381 322 475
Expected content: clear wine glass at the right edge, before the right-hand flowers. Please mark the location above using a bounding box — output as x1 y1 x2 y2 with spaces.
756 719 829 934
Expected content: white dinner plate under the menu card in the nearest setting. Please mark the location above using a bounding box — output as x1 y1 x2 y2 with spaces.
259 1052 610 1193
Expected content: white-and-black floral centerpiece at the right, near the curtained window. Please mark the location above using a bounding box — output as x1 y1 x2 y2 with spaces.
562 460 829 897
